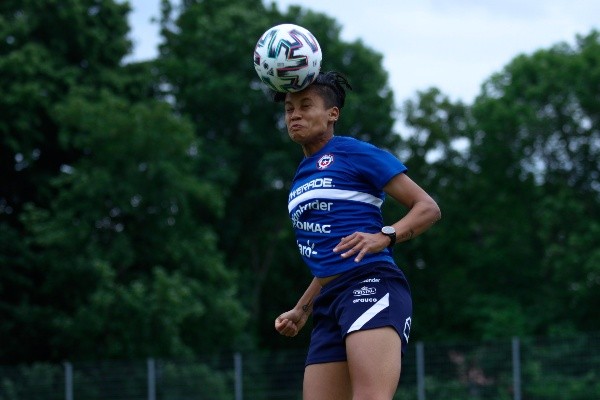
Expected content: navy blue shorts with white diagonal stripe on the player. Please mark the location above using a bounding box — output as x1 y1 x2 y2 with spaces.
306 263 412 365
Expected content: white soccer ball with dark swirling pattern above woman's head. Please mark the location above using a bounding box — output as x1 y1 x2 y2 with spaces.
254 24 323 93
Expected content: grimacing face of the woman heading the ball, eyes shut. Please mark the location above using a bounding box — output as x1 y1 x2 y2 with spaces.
285 86 339 146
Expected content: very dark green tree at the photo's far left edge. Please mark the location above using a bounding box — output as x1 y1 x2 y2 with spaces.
0 1 131 362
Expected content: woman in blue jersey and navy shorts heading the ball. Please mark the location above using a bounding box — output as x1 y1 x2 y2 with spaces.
275 72 441 400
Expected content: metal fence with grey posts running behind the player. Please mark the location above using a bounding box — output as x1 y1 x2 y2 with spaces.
0 334 600 400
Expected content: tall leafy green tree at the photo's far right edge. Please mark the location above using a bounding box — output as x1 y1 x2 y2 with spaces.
473 31 600 333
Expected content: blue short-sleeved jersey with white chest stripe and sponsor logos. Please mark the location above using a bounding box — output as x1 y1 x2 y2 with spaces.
288 136 407 278
